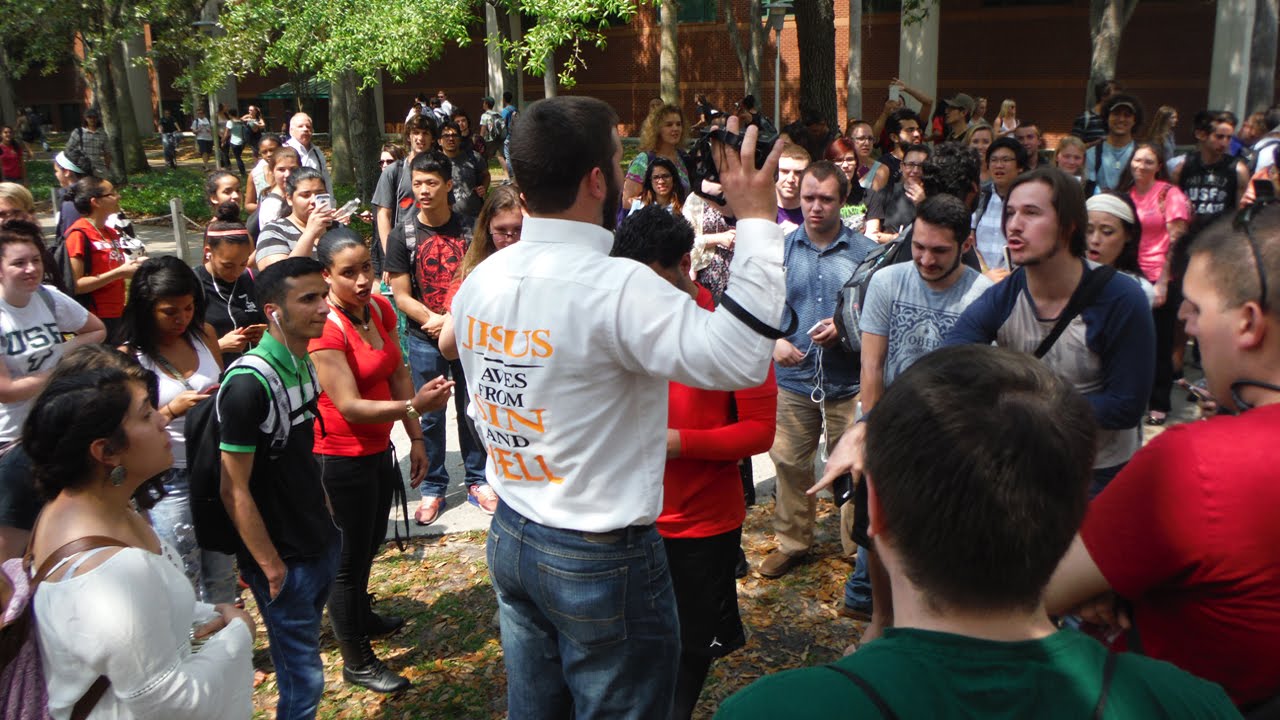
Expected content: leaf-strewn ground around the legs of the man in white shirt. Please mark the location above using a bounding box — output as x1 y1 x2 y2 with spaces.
244 500 863 720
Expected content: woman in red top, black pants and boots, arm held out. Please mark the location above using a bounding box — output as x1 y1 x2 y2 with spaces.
308 229 453 692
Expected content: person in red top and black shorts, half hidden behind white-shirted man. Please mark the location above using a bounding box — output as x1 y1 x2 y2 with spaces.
611 205 778 720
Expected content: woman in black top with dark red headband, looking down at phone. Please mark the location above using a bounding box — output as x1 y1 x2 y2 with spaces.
196 202 266 364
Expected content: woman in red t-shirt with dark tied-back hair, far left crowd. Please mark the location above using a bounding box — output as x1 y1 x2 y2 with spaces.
67 176 142 333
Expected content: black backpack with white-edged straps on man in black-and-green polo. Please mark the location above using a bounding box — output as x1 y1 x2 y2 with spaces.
183 354 320 553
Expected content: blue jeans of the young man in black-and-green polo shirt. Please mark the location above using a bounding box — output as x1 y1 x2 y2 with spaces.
242 537 342 720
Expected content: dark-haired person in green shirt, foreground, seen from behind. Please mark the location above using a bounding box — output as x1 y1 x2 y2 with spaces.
716 346 1239 720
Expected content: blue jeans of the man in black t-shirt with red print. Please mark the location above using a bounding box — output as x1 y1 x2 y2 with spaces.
408 334 486 498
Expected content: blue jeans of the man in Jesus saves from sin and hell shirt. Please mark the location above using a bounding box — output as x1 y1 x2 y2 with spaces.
486 502 680 720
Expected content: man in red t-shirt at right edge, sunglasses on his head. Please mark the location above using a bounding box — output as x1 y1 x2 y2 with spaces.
1047 204 1280 711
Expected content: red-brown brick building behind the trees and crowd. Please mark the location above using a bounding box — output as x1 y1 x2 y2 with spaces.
17 0 1269 142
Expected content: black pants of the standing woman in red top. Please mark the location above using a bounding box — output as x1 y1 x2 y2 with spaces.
316 448 401 641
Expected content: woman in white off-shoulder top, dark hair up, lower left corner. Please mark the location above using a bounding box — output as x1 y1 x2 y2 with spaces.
23 347 255 720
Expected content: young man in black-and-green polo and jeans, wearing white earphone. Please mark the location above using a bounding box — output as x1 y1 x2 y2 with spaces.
218 258 340 720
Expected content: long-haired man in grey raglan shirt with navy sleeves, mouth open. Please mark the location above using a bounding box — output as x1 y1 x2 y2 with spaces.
946 167 1156 497
